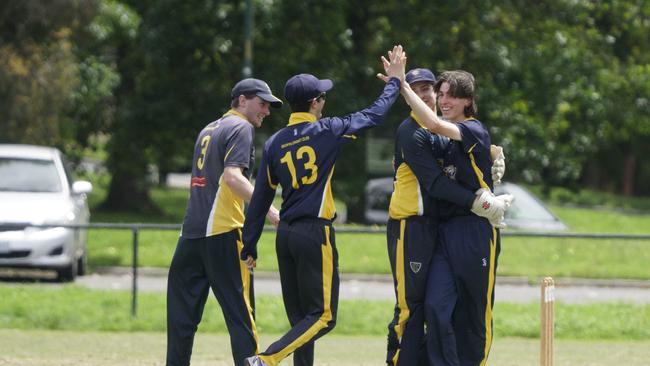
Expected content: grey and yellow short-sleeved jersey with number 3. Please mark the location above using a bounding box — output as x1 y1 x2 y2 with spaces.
181 109 255 238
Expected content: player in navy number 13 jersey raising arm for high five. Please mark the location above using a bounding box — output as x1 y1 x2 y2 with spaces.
241 46 406 366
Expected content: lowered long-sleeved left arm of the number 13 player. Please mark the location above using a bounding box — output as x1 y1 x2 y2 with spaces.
241 149 278 268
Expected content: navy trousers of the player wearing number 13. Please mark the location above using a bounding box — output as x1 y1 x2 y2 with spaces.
260 219 339 366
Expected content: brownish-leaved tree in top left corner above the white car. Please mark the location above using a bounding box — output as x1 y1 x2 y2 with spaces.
0 0 96 150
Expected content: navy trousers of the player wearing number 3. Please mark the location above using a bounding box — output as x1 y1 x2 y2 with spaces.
167 229 259 366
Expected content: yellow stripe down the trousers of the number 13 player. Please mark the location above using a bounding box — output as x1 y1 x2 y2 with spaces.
260 226 334 366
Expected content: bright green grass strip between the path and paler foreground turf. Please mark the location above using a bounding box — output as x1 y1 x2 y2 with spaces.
0 284 650 340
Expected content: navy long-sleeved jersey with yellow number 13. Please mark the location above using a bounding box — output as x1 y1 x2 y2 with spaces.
244 78 400 256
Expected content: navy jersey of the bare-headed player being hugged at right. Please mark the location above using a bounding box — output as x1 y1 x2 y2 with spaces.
441 119 494 217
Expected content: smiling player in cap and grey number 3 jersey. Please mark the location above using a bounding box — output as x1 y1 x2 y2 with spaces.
167 78 282 366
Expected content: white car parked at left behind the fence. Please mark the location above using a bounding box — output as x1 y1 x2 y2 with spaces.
0 144 92 281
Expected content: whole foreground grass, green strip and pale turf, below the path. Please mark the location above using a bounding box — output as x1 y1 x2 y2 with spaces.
0 284 650 366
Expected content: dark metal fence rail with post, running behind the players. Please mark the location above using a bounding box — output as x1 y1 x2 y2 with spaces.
0 223 650 316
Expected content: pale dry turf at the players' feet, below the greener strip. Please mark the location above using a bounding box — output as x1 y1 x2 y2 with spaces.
0 329 650 366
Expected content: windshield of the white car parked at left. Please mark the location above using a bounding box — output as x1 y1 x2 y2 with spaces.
0 157 62 192
